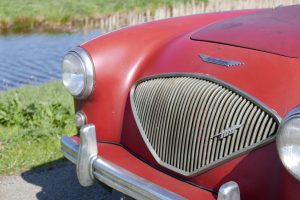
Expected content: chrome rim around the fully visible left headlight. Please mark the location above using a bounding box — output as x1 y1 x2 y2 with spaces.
63 46 95 99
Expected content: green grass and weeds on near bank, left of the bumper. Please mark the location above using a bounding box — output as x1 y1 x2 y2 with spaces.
0 82 76 175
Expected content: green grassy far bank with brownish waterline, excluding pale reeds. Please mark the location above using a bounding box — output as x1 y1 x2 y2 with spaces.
0 0 205 33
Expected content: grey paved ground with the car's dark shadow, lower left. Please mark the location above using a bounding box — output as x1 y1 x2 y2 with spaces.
0 161 111 200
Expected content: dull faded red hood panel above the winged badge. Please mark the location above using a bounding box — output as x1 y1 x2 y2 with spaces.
191 5 300 58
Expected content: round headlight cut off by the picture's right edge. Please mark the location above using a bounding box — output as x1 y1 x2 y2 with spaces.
276 108 300 180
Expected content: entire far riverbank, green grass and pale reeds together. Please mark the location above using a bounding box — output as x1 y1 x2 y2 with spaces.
0 0 300 34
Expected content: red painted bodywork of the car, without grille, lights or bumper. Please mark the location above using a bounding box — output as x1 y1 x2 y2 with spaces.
61 6 300 200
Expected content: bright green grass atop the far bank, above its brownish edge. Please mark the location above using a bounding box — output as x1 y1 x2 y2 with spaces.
0 0 203 22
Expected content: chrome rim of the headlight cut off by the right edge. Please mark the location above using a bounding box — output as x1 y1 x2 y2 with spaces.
276 107 300 181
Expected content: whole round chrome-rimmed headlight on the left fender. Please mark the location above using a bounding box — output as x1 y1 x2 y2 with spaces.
62 47 94 99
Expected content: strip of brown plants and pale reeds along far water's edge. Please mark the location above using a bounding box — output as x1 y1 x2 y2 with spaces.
0 0 300 33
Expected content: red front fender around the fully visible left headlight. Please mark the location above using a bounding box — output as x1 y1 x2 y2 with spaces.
82 11 255 142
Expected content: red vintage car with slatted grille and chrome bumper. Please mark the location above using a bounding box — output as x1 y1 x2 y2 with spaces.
61 5 300 200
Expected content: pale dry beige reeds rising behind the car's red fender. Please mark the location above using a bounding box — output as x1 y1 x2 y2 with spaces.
81 0 300 31
